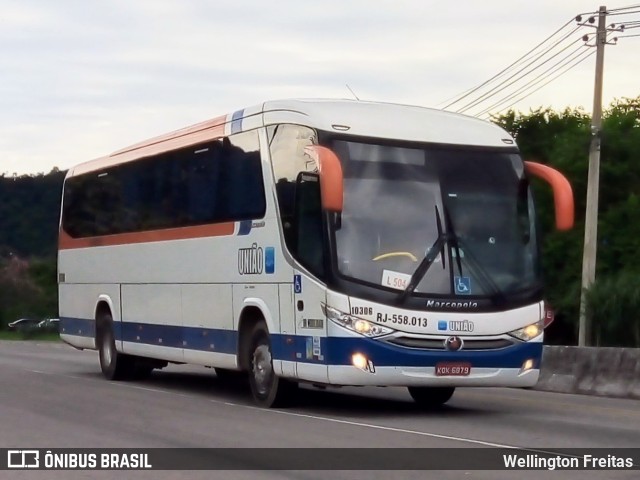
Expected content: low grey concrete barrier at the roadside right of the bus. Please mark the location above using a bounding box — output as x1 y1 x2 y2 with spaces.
535 346 640 399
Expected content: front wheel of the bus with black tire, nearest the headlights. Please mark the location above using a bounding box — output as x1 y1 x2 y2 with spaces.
247 322 298 408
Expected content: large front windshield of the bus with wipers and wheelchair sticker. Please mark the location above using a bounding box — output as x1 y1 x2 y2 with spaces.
328 137 541 297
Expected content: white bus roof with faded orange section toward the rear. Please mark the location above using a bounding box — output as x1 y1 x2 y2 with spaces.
67 99 515 177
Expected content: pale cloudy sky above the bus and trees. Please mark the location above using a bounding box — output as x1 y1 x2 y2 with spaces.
0 0 640 175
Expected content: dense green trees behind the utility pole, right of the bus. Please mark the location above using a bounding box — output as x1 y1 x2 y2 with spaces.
493 97 640 343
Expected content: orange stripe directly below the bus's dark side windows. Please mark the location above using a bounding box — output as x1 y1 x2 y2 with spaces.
58 222 235 250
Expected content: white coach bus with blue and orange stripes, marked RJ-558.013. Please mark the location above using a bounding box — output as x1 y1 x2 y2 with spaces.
58 100 573 407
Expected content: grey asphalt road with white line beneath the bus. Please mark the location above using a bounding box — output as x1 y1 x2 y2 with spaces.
0 341 640 480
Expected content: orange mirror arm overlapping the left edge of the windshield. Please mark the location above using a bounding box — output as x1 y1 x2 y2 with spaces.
305 145 344 213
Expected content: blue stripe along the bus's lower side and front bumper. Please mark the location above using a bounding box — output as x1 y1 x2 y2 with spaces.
60 318 542 368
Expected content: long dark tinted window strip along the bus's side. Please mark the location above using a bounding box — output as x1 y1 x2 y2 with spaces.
63 131 266 237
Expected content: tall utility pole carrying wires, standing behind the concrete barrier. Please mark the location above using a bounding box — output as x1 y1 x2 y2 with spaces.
578 7 607 347
